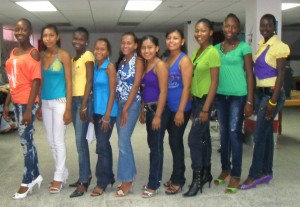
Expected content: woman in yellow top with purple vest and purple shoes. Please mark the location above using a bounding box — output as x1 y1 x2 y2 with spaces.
241 14 290 190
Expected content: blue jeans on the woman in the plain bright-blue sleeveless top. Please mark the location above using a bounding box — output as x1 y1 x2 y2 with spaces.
94 114 116 189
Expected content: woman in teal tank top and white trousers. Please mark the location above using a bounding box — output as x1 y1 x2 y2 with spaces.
40 25 72 193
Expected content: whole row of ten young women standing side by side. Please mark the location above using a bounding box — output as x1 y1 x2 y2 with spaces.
4 11 289 199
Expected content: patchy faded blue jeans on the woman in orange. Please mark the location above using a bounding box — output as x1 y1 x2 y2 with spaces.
15 103 40 184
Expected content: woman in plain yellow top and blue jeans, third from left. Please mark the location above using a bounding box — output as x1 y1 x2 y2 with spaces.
69 27 94 198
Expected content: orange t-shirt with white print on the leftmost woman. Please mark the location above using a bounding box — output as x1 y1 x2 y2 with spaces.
5 48 41 104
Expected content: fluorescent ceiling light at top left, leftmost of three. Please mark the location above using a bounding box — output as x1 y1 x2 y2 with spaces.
16 1 57 12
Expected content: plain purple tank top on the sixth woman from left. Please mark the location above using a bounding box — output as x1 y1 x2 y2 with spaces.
142 68 160 104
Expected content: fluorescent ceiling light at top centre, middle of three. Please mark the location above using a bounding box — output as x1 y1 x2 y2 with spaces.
125 0 162 11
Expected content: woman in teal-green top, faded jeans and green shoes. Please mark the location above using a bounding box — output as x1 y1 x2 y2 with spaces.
214 13 253 193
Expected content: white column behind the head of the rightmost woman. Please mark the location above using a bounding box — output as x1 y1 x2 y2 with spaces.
245 0 282 53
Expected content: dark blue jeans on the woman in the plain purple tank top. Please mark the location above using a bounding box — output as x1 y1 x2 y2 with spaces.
146 105 169 190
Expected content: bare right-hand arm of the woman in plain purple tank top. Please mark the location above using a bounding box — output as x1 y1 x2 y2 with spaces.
152 61 168 130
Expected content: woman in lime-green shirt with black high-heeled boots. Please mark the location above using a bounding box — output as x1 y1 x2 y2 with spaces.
183 19 220 196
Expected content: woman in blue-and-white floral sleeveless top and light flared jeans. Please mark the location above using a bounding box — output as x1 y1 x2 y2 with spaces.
116 32 144 197
